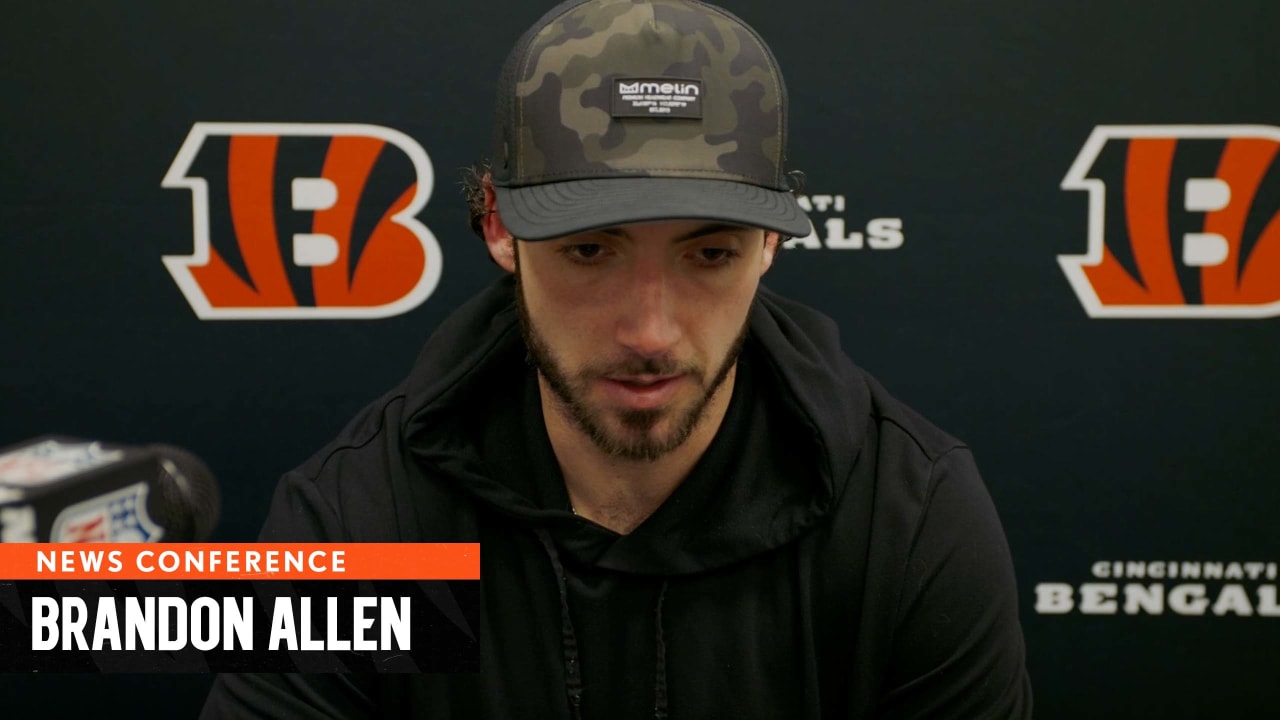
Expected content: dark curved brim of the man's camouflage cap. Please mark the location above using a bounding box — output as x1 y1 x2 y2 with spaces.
494 177 813 240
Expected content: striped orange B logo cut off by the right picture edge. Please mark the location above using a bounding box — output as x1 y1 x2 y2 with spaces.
1059 126 1280 318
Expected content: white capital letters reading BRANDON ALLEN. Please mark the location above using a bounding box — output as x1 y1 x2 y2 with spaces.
31 596 412 652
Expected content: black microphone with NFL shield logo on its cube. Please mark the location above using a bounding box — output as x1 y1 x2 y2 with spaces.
0 436 220 542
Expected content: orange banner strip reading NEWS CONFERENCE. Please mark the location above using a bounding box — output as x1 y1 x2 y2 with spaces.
0 542 480 580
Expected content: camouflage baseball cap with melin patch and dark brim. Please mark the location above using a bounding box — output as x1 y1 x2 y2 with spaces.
492 0 810 240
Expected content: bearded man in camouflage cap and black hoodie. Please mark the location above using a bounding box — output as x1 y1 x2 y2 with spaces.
205 0 1030 719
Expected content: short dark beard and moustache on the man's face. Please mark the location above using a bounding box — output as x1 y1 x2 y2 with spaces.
516 263 748 462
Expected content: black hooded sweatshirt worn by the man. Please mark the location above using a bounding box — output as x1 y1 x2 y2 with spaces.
204 272 1030 720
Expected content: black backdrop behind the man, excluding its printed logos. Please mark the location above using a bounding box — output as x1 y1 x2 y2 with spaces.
0 0 1280 717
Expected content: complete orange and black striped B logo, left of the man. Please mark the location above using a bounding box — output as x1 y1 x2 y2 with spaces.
160 123 442 320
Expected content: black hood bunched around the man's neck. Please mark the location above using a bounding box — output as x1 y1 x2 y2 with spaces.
403 271 870 577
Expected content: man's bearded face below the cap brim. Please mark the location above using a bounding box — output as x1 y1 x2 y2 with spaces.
516 220 777 460
